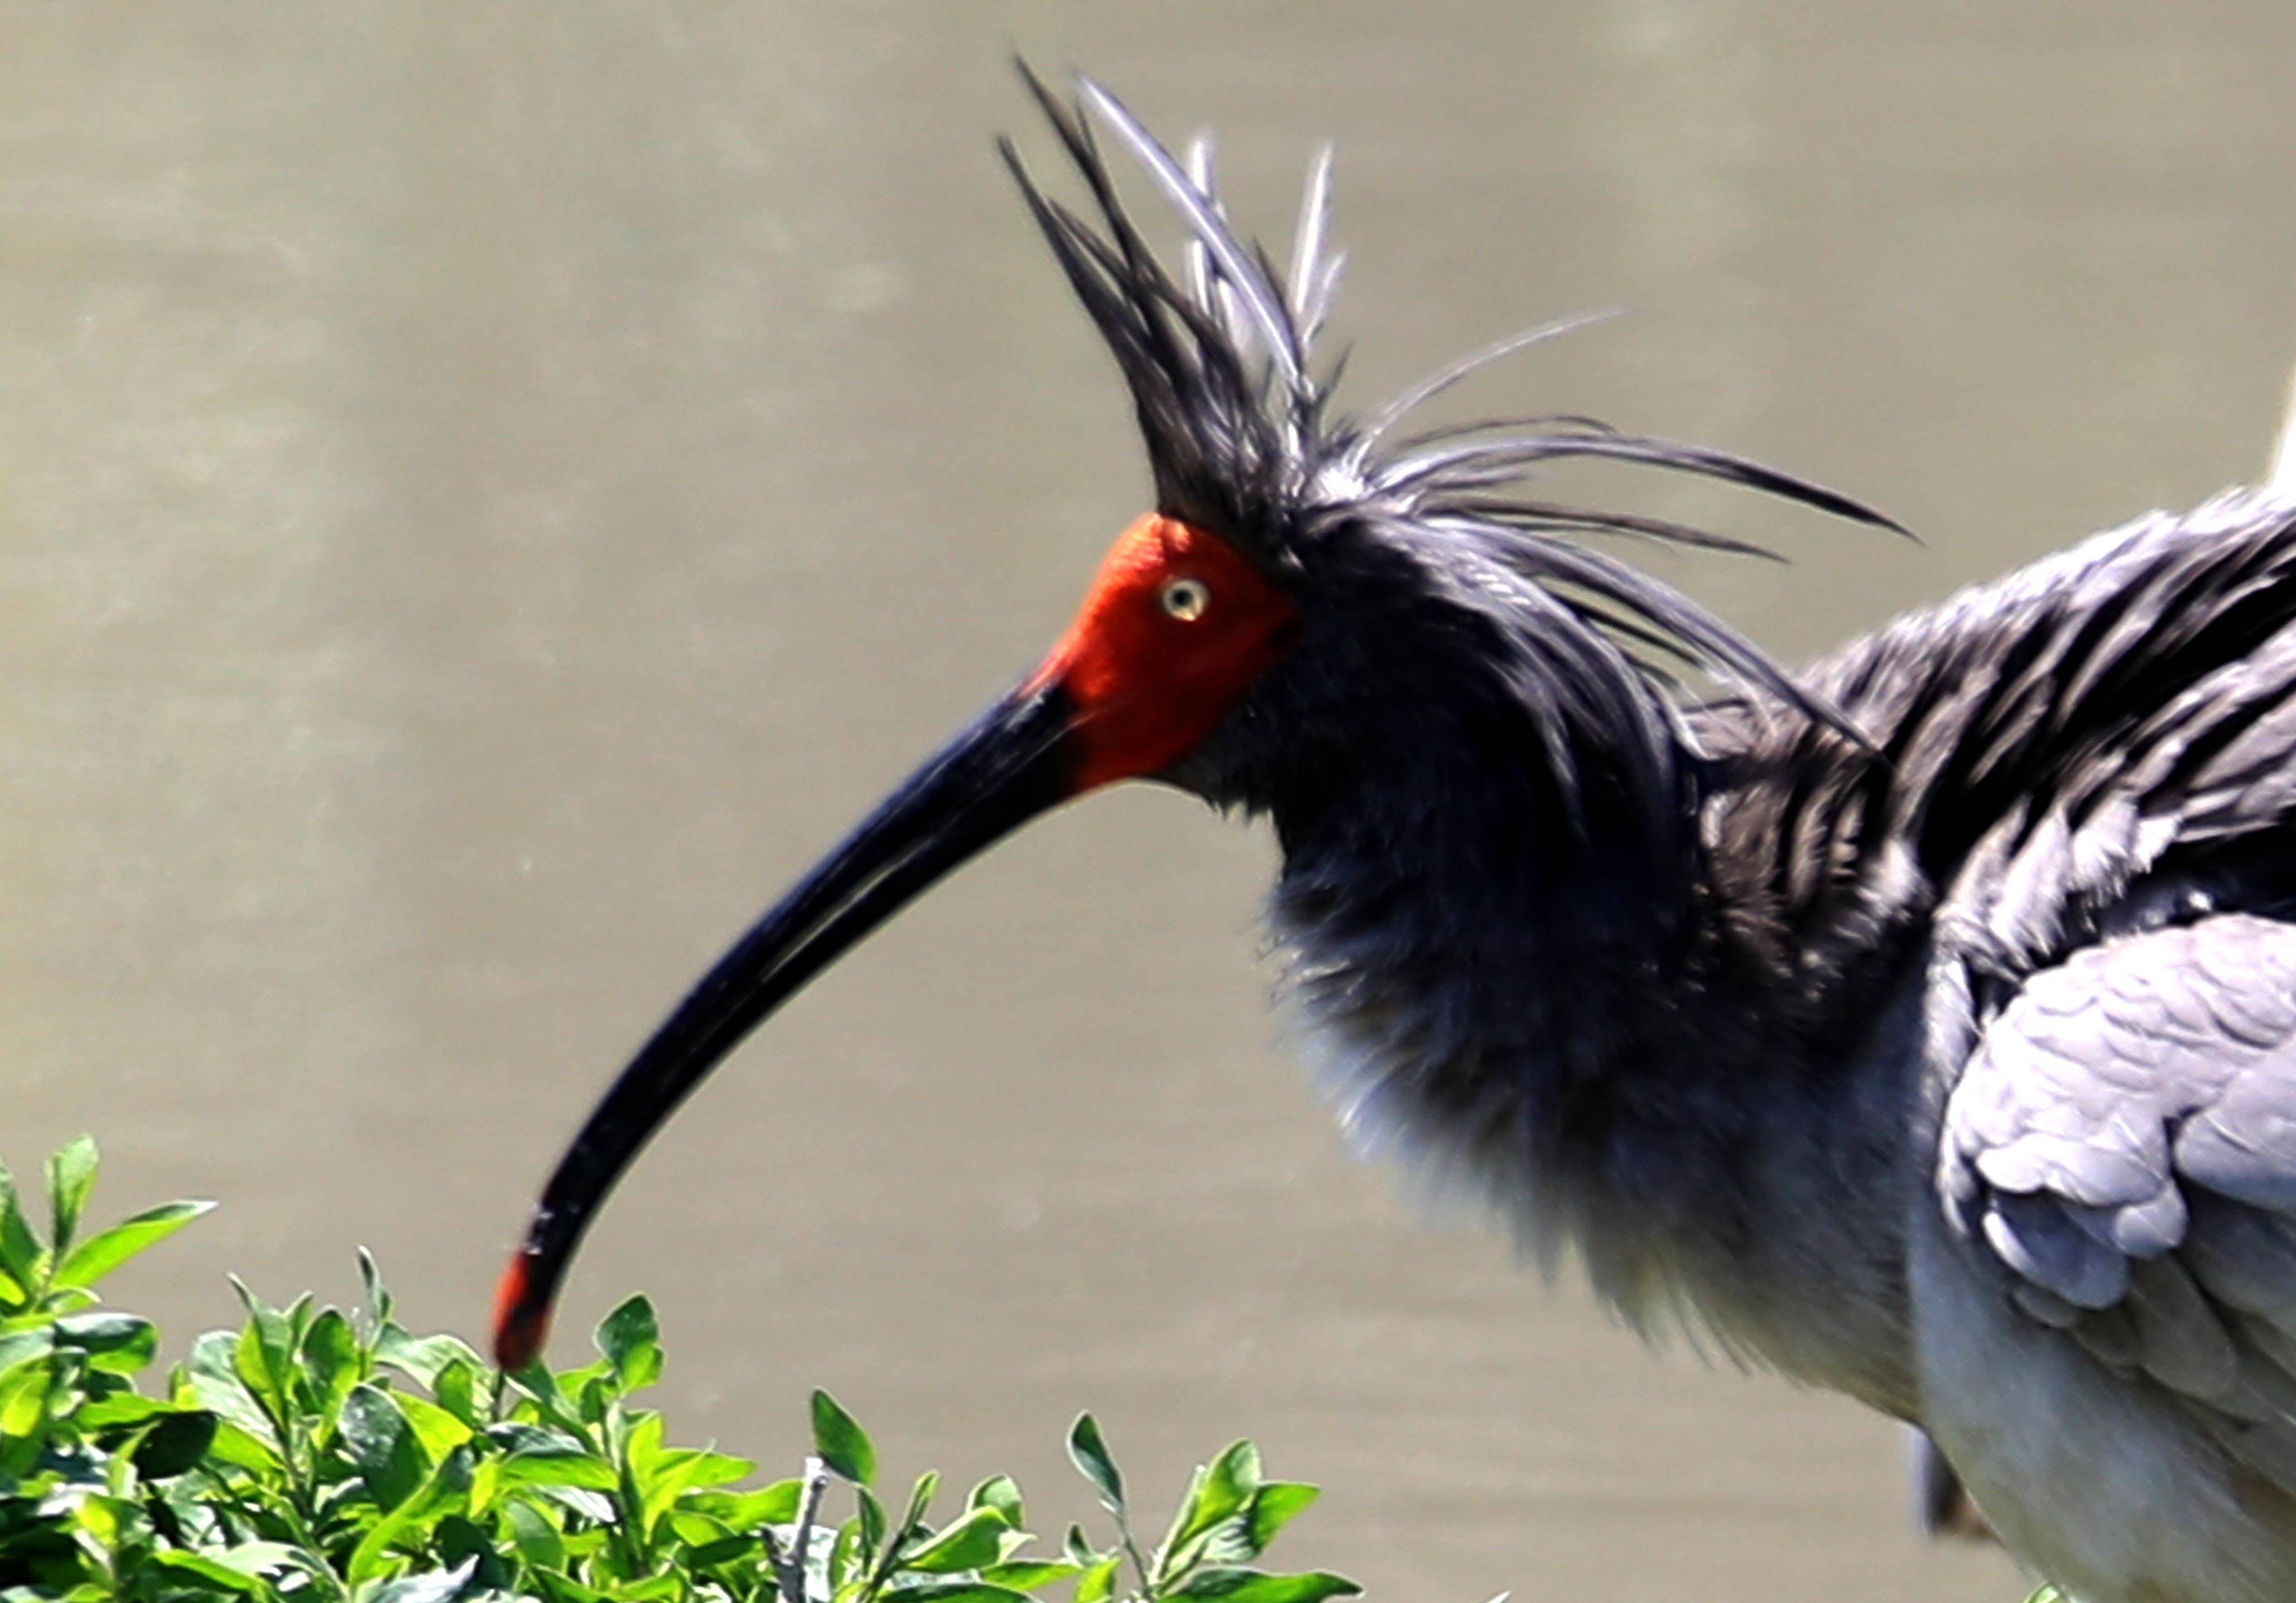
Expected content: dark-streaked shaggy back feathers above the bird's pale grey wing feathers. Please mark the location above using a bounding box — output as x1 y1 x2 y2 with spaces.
1690 494 2296 978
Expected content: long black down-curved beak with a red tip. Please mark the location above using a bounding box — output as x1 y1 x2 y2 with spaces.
494 675 1079 1369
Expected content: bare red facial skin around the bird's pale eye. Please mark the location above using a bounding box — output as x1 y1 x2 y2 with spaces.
1033 512 1297 792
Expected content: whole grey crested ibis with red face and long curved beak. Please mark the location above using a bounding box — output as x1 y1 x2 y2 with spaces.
496 80 2296 1603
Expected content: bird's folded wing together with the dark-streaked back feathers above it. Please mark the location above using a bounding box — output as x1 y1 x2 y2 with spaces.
1692 494 2296 1493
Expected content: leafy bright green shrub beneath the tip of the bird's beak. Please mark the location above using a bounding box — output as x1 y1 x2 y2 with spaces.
0 1137 1357 1603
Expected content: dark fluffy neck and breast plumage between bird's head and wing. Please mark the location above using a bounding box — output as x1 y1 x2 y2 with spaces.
1274 680 1908 1392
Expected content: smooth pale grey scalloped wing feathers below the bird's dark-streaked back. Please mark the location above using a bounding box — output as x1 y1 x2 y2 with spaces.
1938 914 2296 1491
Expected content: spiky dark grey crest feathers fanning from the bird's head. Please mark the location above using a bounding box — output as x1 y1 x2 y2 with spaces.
999 62 1903 739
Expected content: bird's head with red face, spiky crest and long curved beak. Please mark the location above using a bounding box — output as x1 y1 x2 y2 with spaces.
494 67 1887 1369
